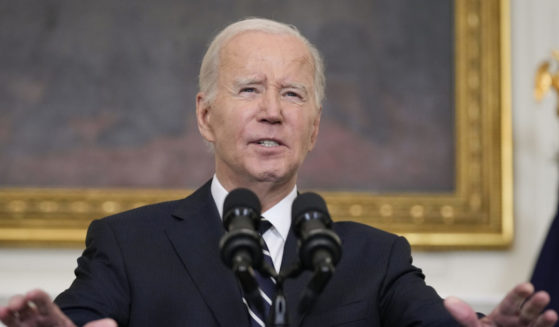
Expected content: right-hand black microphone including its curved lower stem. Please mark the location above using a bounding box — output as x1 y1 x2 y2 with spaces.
291 193 342 313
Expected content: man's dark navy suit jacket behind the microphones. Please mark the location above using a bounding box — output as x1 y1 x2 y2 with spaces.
55 183 455 327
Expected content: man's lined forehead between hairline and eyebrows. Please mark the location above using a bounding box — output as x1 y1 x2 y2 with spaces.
220 31 314 79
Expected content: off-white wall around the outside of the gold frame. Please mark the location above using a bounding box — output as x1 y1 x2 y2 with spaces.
0 0 559 320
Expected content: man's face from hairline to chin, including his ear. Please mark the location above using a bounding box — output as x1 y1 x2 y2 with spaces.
196 32 321 190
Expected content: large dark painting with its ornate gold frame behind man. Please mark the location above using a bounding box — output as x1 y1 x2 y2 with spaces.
0 0 513 250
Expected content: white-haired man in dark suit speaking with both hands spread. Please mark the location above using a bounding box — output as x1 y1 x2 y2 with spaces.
0 19 557 327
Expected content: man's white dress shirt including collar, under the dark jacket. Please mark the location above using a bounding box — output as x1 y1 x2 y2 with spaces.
211 175 297 271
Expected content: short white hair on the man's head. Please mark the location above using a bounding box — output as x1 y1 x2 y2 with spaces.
198 18 326 106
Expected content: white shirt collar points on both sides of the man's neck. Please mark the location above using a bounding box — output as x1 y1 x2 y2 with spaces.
211 174 297 241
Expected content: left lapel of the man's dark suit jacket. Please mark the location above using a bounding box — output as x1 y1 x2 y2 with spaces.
166 182 248 326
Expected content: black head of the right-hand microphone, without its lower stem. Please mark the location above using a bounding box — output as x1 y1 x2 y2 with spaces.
291 192 342 271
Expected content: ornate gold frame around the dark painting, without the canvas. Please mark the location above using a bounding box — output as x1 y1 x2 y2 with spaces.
0 0 513 250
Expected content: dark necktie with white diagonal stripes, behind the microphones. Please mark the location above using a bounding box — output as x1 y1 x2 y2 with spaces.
247 217 276 327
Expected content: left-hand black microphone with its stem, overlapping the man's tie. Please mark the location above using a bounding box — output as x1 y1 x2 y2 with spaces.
219 188 264 312
